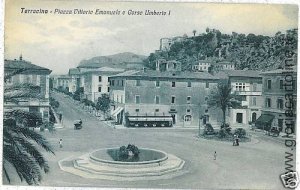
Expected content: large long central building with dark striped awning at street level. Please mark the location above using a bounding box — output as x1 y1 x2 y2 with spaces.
110 70 221 126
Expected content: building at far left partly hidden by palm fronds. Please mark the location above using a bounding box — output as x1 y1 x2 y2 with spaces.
4 56 51 121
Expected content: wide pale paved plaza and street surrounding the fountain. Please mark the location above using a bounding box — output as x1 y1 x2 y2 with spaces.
2 93 287 189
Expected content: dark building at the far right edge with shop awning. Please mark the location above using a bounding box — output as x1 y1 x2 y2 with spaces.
256 67 297 133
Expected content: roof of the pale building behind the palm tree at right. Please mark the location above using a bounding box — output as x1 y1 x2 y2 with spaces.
216 70 262 78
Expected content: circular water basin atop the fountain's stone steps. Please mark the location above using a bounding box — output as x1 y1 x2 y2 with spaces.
90 148 168 165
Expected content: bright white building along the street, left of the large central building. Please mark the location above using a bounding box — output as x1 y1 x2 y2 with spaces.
82 67 124 103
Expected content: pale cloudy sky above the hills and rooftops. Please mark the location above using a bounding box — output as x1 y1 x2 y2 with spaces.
4 0 298 74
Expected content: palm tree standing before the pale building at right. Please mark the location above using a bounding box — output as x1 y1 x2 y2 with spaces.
207 81 240 124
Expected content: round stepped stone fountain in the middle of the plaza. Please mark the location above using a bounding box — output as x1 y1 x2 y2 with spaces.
59 145 185 181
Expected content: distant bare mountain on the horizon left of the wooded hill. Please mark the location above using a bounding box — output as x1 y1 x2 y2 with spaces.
78 52 147 69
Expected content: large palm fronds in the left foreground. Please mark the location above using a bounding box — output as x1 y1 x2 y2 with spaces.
3 70 54 185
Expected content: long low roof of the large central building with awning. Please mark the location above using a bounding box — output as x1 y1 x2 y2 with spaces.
112 70 219 80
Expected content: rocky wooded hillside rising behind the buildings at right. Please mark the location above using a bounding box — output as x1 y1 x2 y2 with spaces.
145 29 298 70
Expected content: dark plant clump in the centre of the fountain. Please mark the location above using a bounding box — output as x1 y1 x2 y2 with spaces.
118 144 140 162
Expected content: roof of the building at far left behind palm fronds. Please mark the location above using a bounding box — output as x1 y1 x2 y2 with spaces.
4 60 52 74
